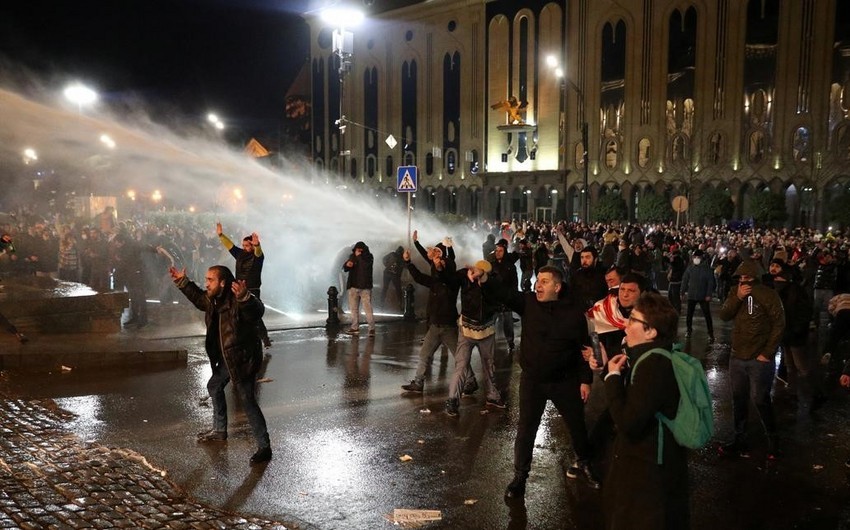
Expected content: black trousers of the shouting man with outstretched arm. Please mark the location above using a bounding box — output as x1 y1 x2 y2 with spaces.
514 373 591 477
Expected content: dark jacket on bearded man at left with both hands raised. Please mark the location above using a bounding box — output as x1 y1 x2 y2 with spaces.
174 276 265 384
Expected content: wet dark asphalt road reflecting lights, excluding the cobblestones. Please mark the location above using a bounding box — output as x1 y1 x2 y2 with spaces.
4 310 850 529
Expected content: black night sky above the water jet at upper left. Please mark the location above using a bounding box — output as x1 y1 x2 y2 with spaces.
0 0 309 135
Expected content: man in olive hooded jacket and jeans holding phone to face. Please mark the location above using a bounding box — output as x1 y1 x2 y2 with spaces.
720 260 785 460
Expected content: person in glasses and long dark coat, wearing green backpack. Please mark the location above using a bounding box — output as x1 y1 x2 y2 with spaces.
603 293 690 530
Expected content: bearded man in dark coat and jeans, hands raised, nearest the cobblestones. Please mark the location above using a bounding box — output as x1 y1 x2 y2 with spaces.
168 265 272 464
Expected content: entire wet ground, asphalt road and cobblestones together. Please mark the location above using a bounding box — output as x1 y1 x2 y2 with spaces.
0 302 850 529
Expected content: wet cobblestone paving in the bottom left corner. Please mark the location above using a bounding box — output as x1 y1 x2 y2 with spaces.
0 395 293 530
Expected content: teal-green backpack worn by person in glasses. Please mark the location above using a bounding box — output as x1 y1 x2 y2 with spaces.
631 346 714 465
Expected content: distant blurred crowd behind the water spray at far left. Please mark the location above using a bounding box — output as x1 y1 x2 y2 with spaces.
0 207 238 325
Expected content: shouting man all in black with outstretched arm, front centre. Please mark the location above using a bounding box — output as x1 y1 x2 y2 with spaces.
505 267 599 498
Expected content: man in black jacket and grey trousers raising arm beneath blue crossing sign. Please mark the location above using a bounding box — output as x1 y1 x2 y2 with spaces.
401 250 478 395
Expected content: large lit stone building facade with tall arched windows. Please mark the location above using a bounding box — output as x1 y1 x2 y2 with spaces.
307 0 850 227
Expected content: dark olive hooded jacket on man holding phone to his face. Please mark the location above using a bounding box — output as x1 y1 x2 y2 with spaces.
720 260 785 360
